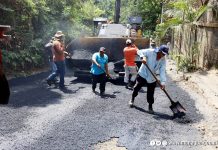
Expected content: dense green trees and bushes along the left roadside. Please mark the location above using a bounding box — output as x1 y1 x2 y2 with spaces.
0 0 104 74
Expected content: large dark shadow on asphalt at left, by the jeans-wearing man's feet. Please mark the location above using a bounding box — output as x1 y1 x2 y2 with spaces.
8 72 85 107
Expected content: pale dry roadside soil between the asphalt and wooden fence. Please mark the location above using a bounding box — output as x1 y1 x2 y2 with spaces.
167 60 218 149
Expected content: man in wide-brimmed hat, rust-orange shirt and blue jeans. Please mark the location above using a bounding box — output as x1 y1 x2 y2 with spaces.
47 31 67 88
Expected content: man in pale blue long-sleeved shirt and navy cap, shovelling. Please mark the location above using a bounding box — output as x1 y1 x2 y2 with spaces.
129 45 169 113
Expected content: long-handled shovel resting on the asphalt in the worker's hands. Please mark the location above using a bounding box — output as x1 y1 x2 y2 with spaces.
145 64 186 118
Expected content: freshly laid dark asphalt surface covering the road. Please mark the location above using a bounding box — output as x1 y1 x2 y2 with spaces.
0 70 206 150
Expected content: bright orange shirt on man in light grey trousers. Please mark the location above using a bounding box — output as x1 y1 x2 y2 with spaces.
123 45 138 66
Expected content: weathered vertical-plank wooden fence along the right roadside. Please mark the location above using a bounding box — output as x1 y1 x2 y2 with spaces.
171 2 218 68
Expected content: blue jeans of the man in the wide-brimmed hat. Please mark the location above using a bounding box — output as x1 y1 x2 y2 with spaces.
47 61 65 87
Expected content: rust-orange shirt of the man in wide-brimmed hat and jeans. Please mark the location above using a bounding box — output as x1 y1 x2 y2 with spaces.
52 41 65 61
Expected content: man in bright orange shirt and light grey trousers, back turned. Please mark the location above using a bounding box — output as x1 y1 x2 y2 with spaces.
123 39 138 88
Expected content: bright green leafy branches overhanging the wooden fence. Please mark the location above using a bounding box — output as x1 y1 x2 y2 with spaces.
156 0 207 38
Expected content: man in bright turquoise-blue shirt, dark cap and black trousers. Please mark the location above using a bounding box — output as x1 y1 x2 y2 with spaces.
91 47 110 95
